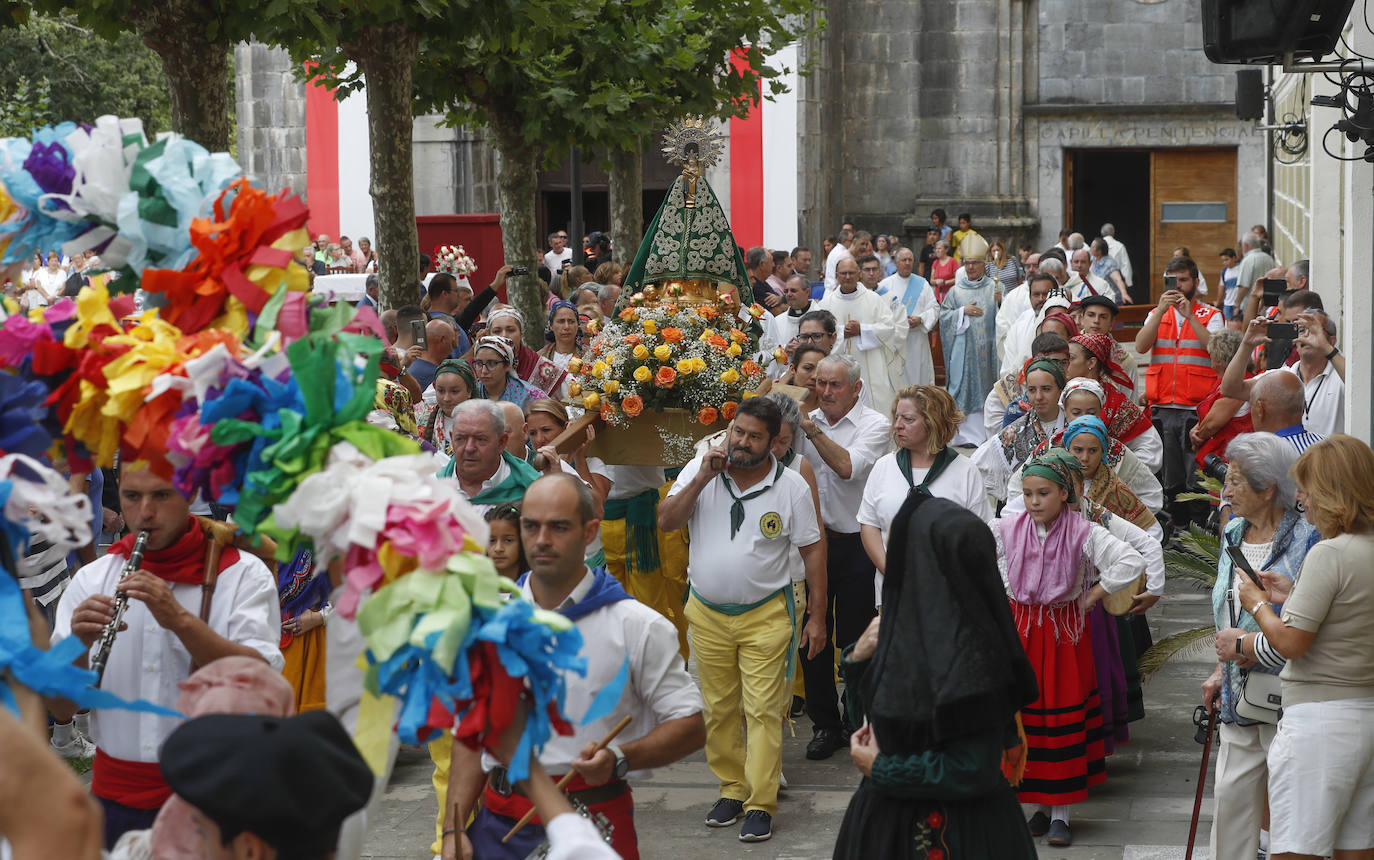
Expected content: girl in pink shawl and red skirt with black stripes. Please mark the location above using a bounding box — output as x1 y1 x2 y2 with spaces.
992 449 1146 846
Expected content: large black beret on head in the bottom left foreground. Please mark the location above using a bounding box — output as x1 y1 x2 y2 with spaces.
159 710 372 856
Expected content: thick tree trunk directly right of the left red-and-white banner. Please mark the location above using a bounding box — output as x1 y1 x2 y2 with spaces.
342 23 423 308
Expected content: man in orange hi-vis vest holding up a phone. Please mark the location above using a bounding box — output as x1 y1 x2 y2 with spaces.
1135 257 1226 525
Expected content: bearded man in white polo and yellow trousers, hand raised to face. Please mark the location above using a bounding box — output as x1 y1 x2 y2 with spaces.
658 397 826 842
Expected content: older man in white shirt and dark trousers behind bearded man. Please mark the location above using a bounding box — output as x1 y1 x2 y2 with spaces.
798 353 892 760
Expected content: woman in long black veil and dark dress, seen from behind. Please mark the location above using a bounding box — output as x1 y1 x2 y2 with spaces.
834 493 1039 860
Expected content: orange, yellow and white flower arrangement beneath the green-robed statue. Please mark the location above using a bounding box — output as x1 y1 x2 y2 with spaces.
569 283 765 427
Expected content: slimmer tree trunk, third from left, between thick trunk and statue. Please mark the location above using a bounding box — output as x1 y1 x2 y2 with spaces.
489 111 545 349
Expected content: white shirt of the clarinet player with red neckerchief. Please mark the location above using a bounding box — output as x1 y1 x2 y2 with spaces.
52 549 286 761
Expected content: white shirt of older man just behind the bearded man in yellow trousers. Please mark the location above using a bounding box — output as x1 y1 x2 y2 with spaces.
797 403 892 534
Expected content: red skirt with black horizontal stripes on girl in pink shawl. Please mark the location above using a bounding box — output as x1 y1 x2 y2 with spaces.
1011 600 1107 805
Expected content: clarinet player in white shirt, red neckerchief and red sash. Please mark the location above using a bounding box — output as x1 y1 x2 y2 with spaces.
52 466 284 849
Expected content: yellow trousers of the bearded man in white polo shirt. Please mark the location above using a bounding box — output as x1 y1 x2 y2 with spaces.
686 585 793 815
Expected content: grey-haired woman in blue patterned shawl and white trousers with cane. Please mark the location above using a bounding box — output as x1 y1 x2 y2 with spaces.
1202 431 1322 860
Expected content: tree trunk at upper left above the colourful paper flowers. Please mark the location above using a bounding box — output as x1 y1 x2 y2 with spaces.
125 0 234 152
